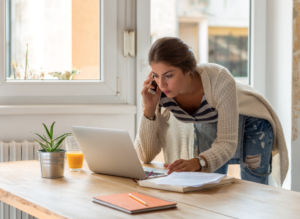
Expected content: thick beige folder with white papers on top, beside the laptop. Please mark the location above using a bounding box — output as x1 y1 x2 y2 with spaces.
138 172 235 192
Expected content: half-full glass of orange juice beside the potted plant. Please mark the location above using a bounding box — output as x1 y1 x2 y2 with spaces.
66 136 83 172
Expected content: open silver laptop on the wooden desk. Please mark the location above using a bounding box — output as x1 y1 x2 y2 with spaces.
72 126 167 179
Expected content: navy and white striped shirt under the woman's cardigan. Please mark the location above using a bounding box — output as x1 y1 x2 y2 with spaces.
159 92 218 123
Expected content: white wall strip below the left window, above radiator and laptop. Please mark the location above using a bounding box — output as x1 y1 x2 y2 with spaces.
0 111 135 142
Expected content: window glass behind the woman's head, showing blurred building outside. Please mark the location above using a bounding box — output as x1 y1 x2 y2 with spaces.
151 0 250 83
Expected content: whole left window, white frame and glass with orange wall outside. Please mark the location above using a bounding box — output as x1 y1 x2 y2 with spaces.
0 0 134 104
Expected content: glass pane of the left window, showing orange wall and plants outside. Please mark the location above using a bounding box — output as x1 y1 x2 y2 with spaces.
6 0 101 82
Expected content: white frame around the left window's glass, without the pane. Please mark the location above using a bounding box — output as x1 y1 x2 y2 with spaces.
0 0 127 104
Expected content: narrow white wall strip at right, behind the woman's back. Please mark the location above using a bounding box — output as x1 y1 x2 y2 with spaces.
264 0 292 189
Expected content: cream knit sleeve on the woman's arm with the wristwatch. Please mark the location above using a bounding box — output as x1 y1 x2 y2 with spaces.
200 68 239 172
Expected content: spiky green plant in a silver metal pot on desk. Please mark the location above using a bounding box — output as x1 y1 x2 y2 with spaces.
33 122 72 179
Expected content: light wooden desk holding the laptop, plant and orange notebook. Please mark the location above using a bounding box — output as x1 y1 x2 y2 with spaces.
0 161 300 218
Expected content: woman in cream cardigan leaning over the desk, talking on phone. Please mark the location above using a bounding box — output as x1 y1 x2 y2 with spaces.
135 37 288 186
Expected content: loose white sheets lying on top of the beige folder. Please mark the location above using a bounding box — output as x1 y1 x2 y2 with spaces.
156 172 225 187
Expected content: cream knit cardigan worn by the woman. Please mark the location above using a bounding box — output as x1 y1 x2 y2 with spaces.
134 63 289 186
